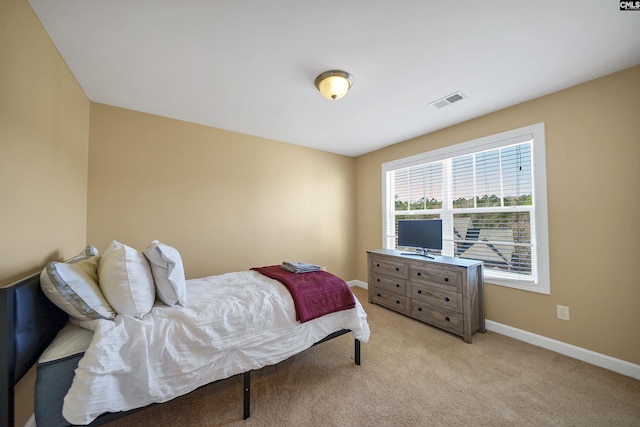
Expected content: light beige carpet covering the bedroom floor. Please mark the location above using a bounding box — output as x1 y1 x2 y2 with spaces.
109 288 640 427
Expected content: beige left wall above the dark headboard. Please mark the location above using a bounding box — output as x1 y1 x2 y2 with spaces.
0 0 89 425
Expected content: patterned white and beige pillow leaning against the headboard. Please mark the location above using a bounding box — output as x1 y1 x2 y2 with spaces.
40 256 116 320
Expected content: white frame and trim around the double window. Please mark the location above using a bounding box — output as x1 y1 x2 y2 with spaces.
382 123 551 294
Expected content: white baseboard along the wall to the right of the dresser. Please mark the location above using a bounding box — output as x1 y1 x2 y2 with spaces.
485 320 640 380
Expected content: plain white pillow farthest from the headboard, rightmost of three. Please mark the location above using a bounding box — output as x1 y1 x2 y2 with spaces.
142 240 187 307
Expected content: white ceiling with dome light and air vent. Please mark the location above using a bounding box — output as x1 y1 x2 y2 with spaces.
29 0 640 156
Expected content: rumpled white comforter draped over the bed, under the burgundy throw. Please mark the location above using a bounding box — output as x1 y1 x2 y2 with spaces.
63 271 369 424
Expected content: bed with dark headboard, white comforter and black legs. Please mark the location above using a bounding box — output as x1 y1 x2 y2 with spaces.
0 242 369 426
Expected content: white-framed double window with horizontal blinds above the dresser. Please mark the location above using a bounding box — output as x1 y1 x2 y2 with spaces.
382 123 549 294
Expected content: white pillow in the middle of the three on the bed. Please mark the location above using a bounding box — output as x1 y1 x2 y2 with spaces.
98 240 156 318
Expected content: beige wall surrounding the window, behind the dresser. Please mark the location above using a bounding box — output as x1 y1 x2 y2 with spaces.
356 66 640 364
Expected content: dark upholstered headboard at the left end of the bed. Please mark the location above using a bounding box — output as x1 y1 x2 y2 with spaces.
0 273 68 427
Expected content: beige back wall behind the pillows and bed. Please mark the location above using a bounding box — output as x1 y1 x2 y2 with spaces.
87 104 355 279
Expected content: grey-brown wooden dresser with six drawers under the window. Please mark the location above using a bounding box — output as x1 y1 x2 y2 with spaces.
367 249 486 343
